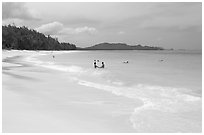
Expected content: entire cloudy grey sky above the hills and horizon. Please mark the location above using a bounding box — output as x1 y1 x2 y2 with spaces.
2 2 202 50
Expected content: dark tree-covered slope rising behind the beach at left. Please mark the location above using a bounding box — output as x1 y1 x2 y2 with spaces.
2 25 76 50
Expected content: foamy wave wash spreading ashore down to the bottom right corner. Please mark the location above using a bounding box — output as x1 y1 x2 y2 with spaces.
78 80 202 132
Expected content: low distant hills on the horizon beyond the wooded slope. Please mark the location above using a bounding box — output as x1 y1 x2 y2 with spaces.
80 43 164 50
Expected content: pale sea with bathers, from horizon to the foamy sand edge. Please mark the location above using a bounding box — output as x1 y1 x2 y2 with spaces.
27 50 202 132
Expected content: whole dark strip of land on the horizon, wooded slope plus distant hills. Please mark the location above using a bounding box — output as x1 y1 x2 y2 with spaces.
2 25 164 50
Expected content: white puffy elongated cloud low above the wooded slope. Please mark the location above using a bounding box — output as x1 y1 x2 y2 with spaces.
36 22 97 35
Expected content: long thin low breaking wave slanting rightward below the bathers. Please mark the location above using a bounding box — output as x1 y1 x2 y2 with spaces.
78 80 201 102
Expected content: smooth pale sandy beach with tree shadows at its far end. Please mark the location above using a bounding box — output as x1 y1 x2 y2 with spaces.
2 51 140 133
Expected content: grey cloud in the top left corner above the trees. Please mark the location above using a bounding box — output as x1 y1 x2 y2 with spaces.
2 2 39 20
